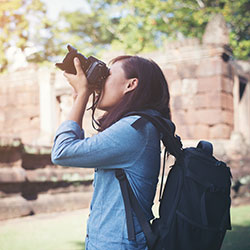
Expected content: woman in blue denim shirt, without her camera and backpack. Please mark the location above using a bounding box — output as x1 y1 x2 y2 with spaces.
52 56 170 250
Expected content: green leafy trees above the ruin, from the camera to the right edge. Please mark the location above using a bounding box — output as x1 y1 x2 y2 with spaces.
58 0 250 59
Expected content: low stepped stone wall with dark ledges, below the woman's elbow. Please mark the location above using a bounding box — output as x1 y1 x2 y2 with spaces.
0 139 94 220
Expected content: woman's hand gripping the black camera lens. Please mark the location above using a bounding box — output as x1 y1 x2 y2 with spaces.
63 57 93 96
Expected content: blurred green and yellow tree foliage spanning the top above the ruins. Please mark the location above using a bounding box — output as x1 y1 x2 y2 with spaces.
0 0 250 72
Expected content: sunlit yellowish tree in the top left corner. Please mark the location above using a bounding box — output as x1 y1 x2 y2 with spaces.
0 0 57 72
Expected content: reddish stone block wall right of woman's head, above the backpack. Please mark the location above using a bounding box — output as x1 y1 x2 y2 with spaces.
163 45 234 139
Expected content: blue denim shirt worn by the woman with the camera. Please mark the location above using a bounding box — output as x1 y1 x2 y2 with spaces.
51 116 160 250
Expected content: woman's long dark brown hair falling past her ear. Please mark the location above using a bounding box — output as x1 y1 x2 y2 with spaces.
94 56 171 131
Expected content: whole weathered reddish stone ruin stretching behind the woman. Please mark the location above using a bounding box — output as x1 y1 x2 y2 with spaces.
0 15 250 220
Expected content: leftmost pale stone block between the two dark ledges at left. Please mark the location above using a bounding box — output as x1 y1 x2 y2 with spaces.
0 167 26 183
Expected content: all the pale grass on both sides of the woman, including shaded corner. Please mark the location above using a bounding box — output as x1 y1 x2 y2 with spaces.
0 205 250 250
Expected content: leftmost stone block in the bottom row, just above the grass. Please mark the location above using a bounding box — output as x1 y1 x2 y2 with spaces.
0 196 32 220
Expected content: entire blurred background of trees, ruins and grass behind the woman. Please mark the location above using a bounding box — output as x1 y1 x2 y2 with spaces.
0 0 250 250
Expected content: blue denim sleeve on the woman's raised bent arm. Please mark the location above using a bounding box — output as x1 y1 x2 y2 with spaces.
51 116 146 168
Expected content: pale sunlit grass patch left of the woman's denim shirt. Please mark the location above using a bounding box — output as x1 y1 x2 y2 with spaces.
0 210 88 250
